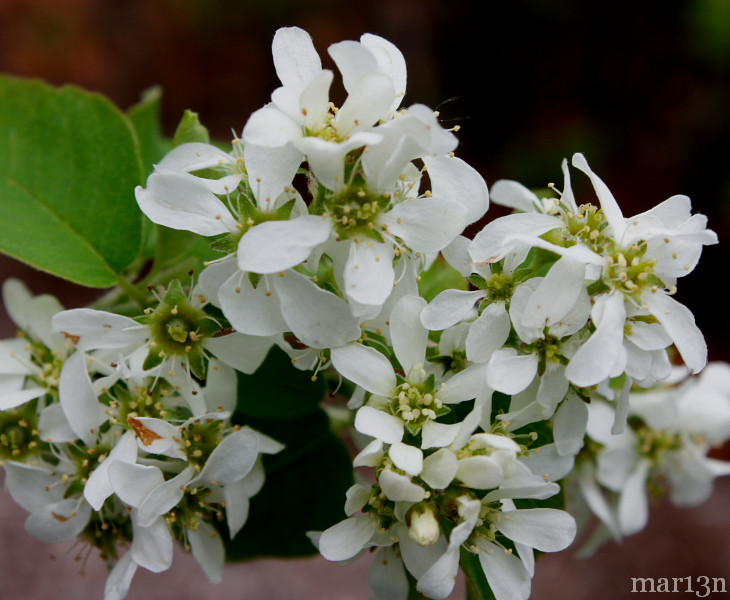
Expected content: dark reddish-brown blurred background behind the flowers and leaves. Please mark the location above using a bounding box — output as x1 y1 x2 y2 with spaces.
0 0 730 600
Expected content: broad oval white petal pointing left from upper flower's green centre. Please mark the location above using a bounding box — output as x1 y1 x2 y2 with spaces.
238 215 332 273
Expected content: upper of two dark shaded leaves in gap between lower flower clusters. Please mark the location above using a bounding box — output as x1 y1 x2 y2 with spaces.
236 346 326 419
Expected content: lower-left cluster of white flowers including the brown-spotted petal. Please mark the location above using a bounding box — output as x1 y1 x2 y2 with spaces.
0 279 282 600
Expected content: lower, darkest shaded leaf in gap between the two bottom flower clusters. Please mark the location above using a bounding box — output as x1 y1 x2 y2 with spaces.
226 410 352 560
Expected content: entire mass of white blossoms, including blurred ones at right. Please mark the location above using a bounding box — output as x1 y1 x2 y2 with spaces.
0 28 730 600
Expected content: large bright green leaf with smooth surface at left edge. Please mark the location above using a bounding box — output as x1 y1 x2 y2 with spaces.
0 77 143 287
